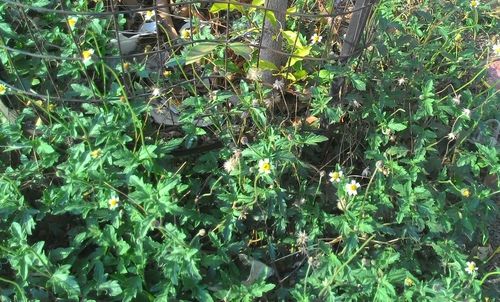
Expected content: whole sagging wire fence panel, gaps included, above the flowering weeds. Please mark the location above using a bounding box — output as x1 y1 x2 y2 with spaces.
0 0 376 115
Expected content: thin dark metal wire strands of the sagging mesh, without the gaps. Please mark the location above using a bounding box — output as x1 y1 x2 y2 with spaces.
0 0 376 102
